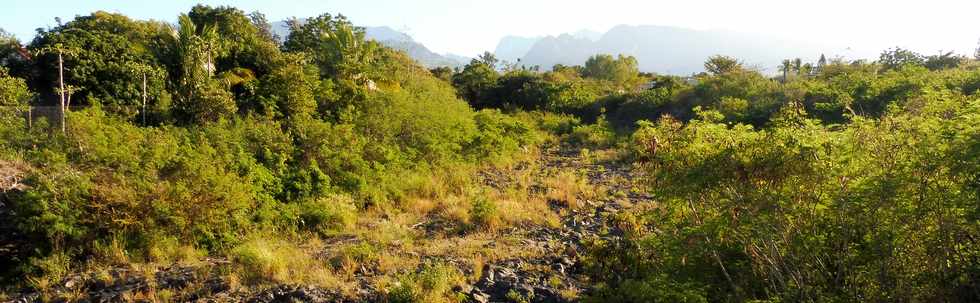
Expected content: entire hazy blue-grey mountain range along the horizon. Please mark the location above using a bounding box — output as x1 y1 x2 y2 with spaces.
272 22 874 75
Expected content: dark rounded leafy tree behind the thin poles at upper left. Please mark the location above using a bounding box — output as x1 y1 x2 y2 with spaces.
29 12 170 115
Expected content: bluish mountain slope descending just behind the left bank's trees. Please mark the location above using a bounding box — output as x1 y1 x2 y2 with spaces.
272 21 469 68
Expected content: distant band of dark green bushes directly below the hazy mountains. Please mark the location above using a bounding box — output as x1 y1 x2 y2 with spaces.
454 57 980 139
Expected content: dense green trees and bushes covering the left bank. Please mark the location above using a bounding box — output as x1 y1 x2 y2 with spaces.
0 6 538 284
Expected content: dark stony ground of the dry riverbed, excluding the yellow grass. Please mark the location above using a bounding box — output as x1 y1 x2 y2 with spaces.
8 146 651 302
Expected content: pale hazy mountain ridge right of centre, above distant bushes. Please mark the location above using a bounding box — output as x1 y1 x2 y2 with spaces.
498 25 856 75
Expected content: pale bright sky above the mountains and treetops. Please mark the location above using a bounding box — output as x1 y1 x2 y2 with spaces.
0 0 980 56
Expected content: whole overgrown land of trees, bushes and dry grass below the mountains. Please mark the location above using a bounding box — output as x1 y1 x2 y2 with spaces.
0 6 980 302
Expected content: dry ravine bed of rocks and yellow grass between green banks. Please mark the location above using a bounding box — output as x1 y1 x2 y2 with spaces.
0 145 650 302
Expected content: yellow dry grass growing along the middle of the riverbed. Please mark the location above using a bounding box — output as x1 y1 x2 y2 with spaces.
17 138 605 302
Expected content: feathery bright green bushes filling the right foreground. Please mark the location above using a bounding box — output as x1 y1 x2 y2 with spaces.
590 90 980 301
